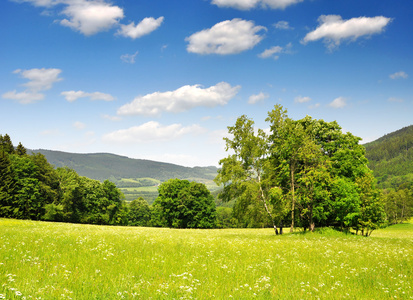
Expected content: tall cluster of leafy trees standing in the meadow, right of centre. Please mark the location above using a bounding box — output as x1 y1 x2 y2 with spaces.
215 105 385 235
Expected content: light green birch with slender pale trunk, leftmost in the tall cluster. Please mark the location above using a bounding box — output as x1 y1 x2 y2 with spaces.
215 115 278 234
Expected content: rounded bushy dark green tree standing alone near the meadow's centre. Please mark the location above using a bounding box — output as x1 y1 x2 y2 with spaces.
154 179 216 228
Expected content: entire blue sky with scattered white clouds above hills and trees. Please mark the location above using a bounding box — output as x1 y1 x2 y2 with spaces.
0 0 413 166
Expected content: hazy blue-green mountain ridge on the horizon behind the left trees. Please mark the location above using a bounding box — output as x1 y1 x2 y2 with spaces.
29 149 218 181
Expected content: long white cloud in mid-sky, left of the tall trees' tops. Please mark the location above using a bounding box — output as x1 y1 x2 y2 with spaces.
118 82 241 115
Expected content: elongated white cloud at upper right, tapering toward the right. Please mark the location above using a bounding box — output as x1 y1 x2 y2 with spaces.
302 15 391 50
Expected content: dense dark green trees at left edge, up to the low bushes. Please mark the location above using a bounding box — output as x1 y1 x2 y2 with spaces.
0 134 128 225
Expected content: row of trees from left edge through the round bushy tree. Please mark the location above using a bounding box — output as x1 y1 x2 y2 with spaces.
0 134 216 228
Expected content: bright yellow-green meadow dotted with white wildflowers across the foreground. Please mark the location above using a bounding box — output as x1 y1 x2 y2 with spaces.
0 219 413 299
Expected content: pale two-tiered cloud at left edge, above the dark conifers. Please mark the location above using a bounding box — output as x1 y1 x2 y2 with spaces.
2 68 62 104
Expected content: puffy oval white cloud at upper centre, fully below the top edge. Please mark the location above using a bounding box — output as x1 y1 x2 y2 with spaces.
185 19 266 55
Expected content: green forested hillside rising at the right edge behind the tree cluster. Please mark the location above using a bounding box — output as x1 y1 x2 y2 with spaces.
364 125 413 188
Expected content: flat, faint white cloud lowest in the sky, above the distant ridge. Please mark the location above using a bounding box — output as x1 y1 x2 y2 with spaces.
103 121 205 143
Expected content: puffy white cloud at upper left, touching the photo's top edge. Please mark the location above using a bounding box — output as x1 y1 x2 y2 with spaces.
60 0 124 35
